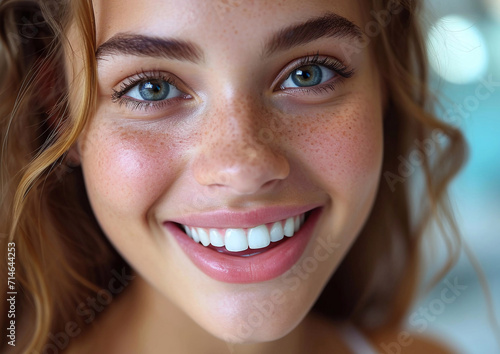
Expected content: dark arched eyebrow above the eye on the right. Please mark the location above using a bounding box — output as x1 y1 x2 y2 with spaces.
264 13 364 56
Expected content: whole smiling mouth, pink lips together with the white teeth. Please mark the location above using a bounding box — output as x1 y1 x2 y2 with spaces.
167 209 323 284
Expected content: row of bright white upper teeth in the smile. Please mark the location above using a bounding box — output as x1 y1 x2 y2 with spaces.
182 214 305 252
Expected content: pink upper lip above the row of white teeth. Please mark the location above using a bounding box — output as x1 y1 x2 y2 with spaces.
168 204 321 229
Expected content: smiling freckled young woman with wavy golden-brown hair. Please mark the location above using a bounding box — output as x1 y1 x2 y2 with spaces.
0 0 464 353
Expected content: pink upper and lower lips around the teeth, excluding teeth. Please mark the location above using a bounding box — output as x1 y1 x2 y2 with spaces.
164 207 322 284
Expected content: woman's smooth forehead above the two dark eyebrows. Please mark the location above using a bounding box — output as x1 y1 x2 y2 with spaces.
94 0 363 49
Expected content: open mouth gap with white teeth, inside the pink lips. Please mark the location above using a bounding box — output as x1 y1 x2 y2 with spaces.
176 211 310 257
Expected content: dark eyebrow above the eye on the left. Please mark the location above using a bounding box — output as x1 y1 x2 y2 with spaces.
95 33 203 63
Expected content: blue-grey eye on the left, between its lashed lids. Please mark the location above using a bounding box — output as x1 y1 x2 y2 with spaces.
125 79 184 101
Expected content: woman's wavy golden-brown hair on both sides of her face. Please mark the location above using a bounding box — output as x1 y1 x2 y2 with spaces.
0 0 465 351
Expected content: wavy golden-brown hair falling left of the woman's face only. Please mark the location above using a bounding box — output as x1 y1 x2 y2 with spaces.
0 1 122 352
